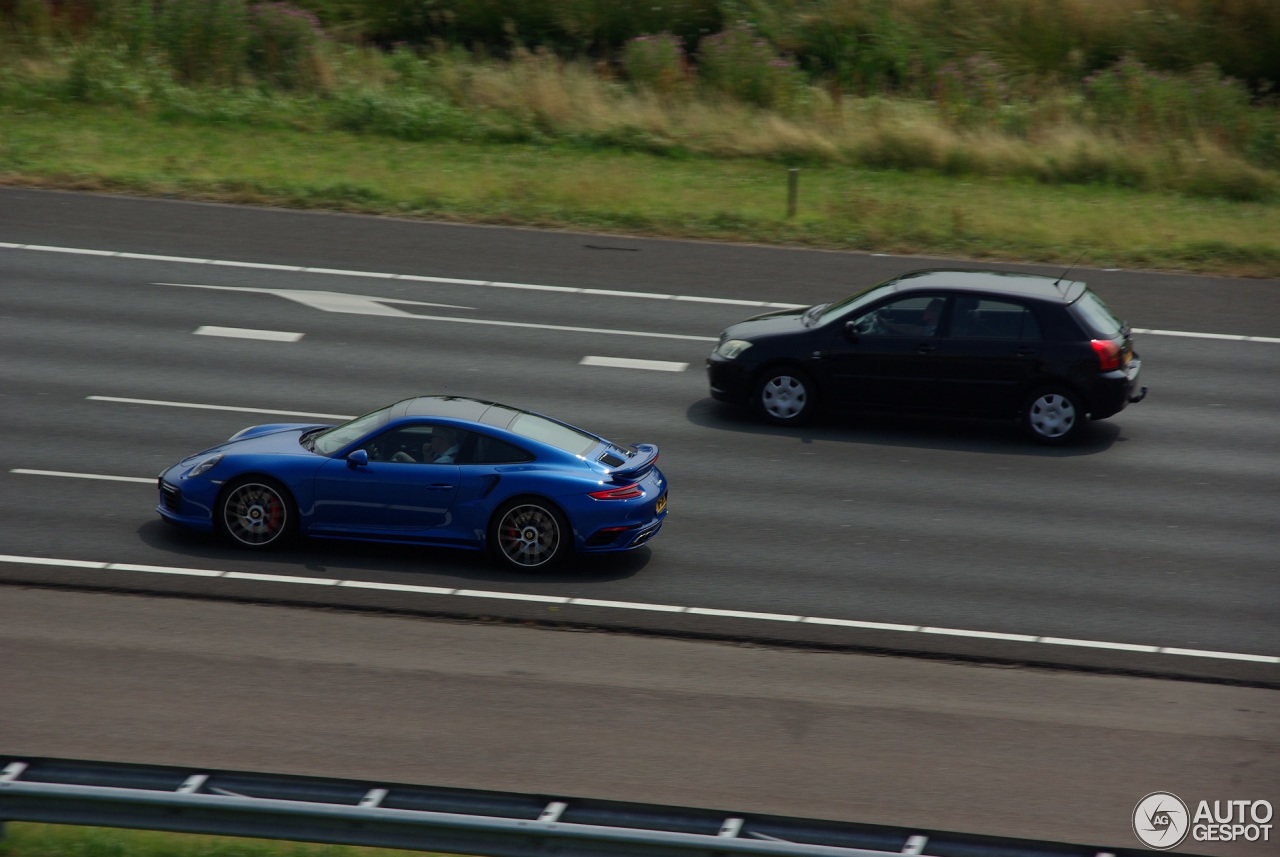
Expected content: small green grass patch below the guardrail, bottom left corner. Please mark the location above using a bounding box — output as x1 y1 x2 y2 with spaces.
0 821 445 857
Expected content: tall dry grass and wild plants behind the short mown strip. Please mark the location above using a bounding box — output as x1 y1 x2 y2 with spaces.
0 0 1280 201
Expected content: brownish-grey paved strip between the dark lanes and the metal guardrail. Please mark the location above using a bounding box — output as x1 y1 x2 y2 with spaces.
0 587 1280 857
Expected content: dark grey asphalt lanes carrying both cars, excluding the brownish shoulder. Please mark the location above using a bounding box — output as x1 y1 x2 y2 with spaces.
0 191 1280 680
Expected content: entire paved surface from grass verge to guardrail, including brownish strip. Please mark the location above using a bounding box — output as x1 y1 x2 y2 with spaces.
0 189 1280 854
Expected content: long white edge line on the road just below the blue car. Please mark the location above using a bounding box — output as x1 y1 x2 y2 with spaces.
0 555 1280 664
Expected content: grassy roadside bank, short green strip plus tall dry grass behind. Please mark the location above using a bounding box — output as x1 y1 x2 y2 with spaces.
0 0 1280 276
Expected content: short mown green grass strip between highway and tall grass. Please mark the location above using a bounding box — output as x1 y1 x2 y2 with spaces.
0 104 1280 276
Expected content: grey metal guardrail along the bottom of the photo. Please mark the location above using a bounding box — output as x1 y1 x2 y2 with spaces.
0 756 1147 857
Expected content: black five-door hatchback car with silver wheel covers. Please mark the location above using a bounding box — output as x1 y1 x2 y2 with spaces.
707 270 1147 444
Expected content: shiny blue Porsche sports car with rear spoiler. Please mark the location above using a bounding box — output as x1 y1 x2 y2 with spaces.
156 395 667 570
